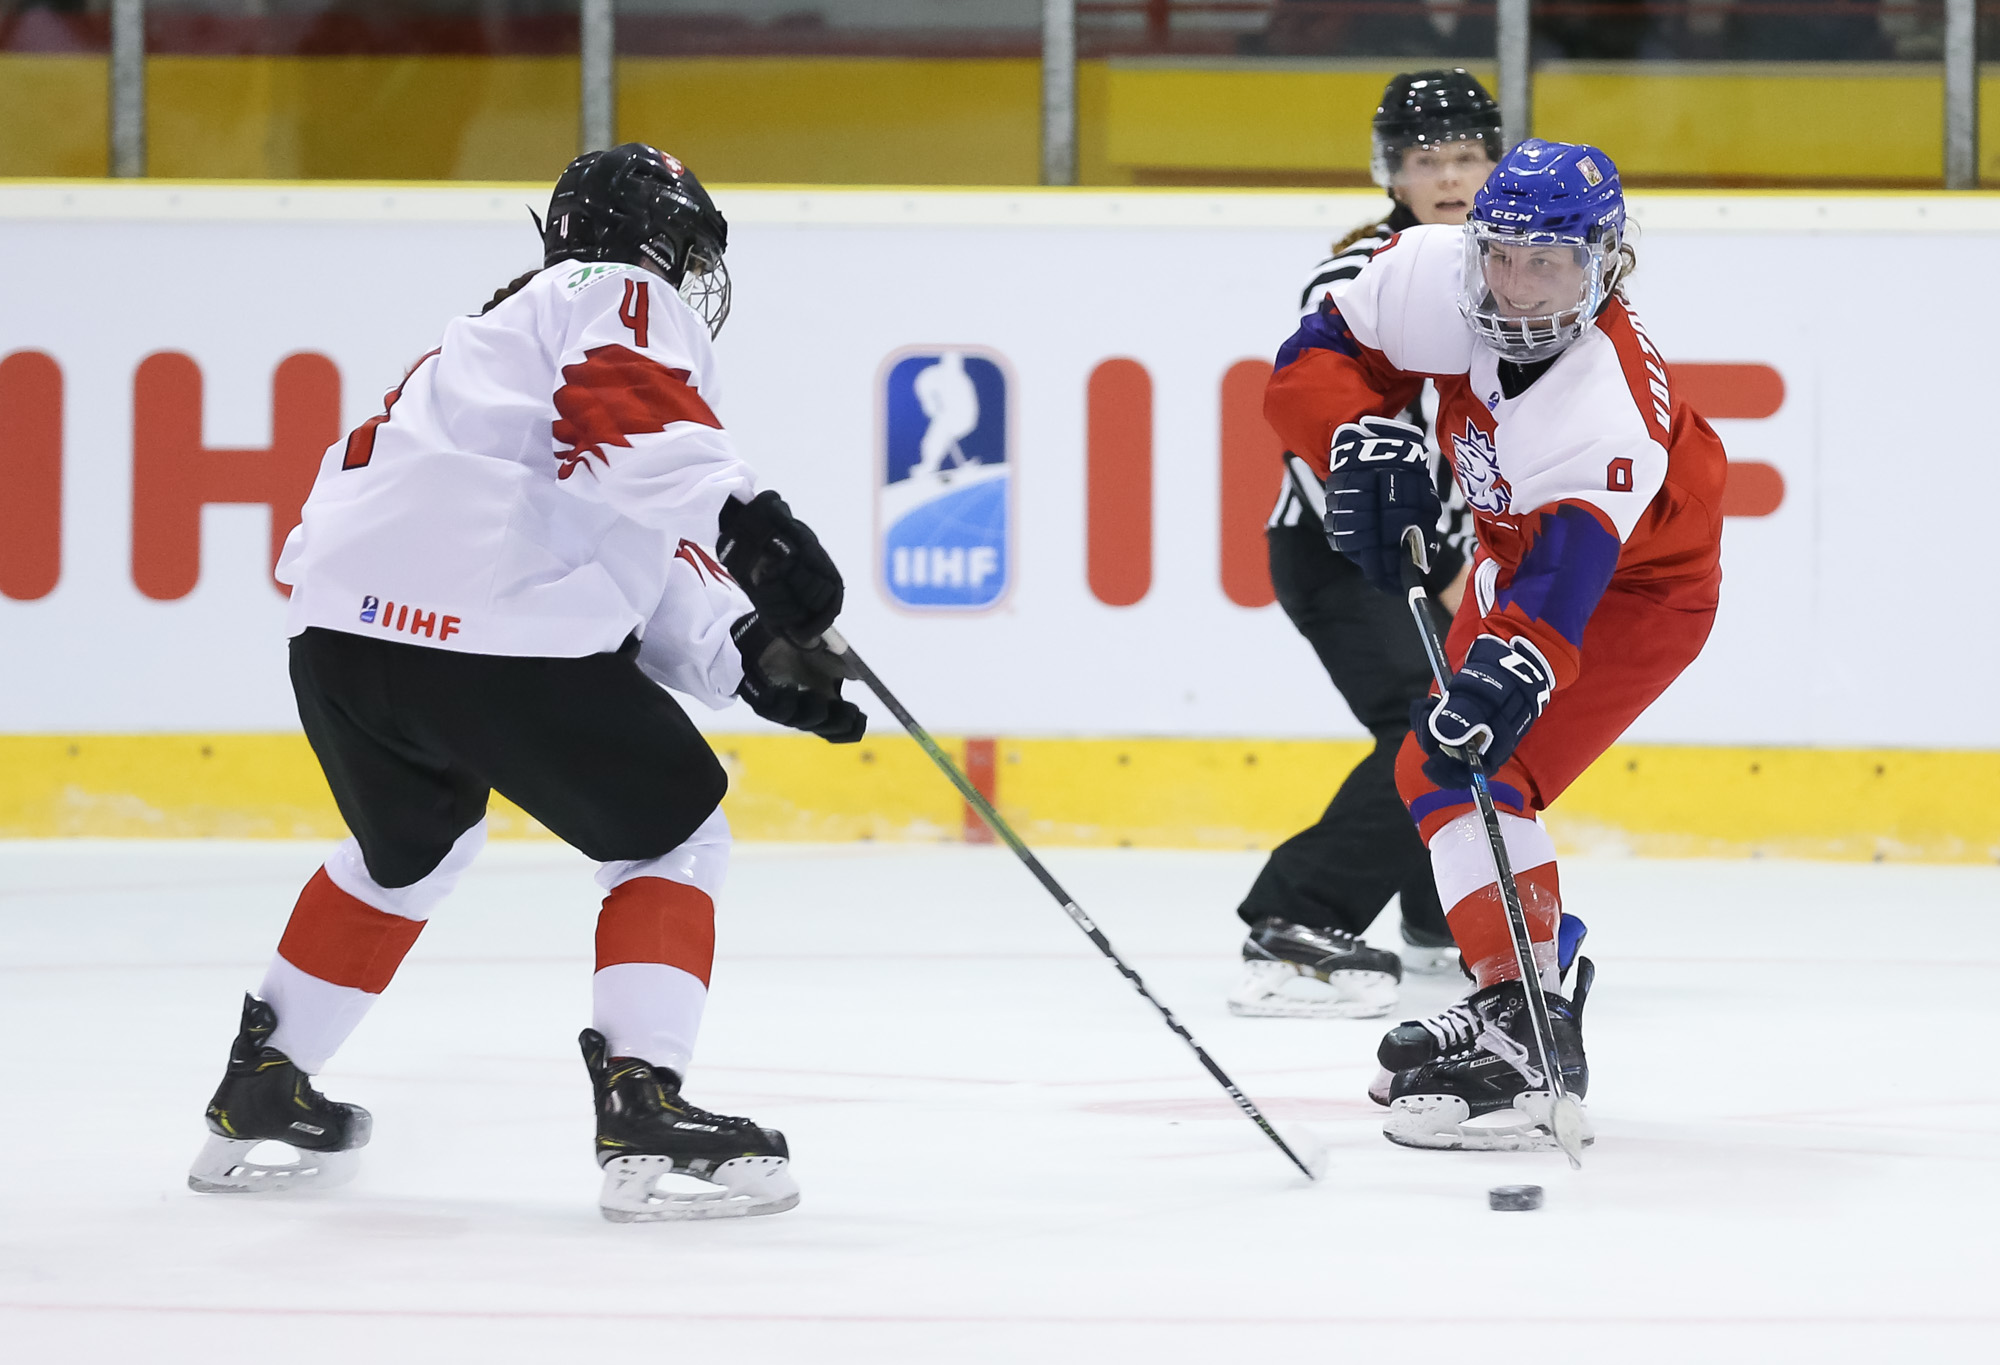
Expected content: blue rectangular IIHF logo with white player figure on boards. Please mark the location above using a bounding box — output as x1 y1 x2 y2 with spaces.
876 346 1014 610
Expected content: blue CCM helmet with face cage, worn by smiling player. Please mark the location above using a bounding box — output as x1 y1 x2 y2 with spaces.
1458 138 1626 362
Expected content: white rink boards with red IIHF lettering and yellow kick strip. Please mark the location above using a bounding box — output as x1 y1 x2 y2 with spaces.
0 182 2000 859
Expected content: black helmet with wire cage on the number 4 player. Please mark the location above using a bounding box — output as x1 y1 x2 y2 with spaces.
542 142 730 336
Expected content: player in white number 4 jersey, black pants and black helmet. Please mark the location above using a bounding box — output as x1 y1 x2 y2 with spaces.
188 142 866 1221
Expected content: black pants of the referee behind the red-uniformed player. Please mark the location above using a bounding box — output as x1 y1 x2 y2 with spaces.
1236 514 1452 947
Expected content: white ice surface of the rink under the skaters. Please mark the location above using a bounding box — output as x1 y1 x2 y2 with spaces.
0 843 2000 1365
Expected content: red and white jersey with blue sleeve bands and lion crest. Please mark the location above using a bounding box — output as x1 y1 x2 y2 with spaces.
1264 226 1726 689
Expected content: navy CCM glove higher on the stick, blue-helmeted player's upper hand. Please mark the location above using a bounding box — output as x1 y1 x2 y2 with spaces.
1326 416 1444 592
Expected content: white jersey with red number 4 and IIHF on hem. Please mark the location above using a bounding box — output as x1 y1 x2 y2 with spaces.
278 262 756 707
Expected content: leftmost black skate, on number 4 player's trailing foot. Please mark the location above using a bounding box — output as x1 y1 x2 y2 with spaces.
188 995 374 1195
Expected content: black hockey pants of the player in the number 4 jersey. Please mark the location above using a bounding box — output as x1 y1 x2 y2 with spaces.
292 628 728 887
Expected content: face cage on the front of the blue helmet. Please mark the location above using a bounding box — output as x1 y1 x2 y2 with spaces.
1458 222 1618 364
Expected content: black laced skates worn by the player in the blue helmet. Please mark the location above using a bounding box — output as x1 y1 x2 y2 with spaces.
1382 959 1594 1151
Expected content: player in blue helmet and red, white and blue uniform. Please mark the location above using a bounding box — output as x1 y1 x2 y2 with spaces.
1264 140 1726 1149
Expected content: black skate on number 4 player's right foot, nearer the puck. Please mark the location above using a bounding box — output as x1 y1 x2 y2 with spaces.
576 1029 798 1223
